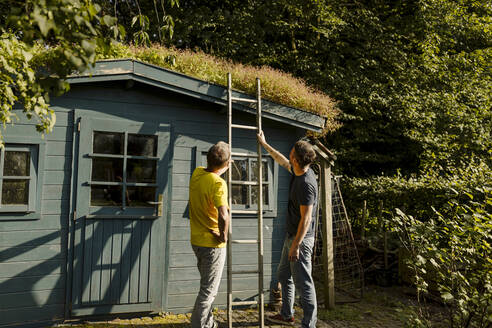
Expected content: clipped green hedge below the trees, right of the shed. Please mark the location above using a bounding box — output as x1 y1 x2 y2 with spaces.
340 161 492 235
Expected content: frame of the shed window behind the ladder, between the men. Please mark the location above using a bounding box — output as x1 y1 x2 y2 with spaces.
195 148 278 217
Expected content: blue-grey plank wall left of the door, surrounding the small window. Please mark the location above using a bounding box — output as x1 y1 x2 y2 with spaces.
0 107 73 327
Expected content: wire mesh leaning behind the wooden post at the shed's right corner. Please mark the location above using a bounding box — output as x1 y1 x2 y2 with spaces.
313 177 364 303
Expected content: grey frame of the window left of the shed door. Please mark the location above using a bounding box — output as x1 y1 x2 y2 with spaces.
0 136 46 221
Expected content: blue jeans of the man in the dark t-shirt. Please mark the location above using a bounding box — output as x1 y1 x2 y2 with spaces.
277 237 317 328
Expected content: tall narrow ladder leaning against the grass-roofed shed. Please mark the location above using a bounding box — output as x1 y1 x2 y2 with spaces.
227 73 265 328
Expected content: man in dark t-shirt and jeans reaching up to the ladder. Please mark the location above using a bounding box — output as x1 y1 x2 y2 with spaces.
258 131 318 328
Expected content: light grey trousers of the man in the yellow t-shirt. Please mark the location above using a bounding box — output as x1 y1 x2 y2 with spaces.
191 245 226 328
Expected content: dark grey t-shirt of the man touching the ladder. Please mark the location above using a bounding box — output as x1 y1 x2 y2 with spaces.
286 168 318 237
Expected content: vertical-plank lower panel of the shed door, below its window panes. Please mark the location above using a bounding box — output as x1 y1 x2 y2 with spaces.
77 220 152 306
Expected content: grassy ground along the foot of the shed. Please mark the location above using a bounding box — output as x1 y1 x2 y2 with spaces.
52 286 446 328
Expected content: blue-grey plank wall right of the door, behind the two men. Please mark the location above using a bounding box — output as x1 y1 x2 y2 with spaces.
167 138 292 312
